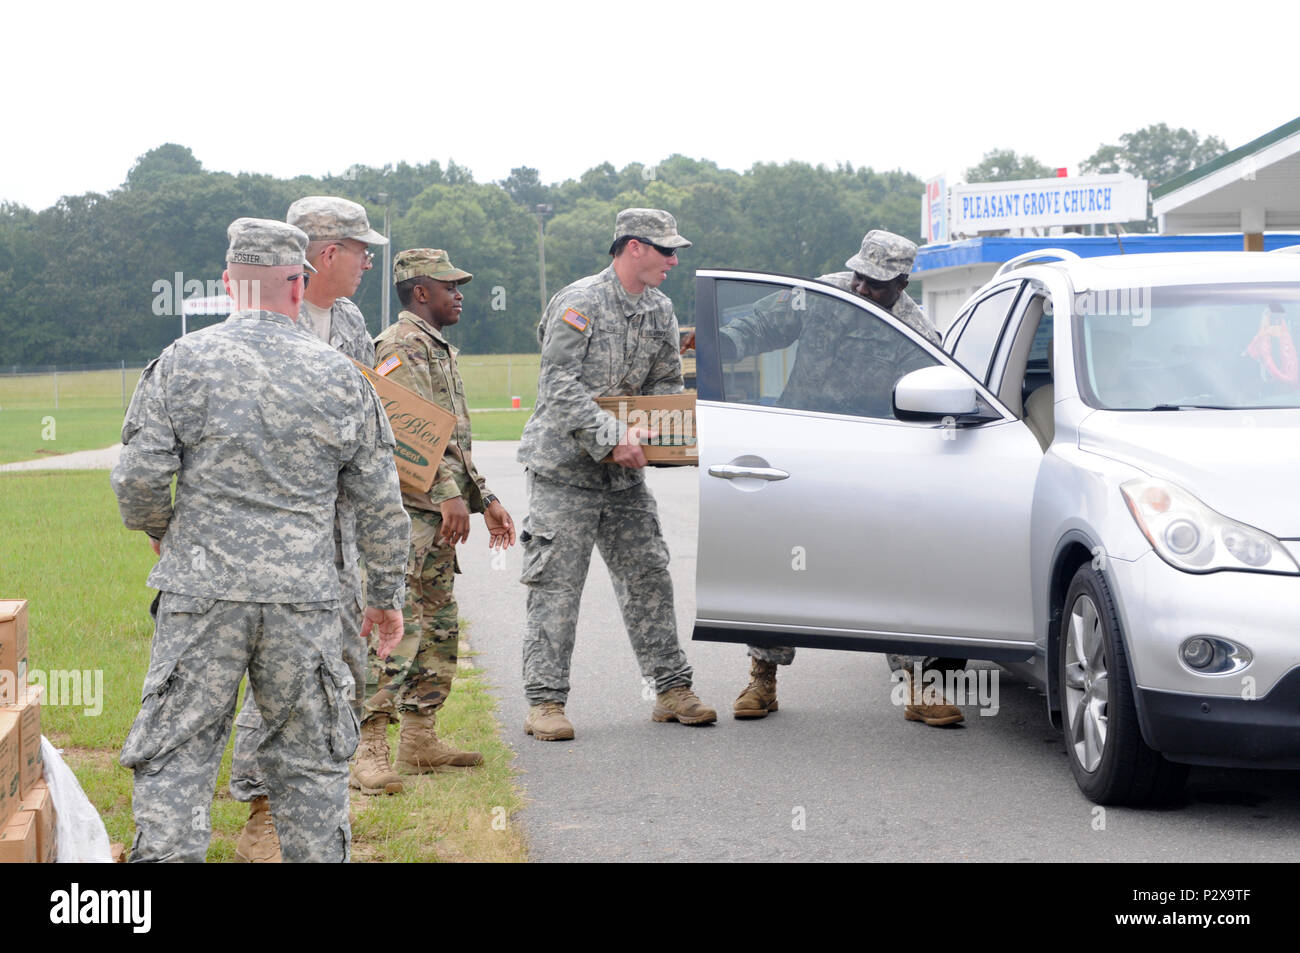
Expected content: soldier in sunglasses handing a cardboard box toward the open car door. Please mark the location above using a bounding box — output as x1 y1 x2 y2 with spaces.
519 208 718 741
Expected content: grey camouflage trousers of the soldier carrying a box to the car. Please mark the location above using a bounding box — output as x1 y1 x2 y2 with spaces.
520 471 692 705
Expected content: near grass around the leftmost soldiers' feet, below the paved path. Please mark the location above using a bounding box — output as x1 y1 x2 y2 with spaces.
0 471 527 861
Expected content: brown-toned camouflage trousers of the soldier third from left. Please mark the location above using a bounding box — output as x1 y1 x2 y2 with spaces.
363 510 460 722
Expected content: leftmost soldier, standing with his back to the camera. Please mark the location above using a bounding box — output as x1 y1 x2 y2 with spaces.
112 218 408 862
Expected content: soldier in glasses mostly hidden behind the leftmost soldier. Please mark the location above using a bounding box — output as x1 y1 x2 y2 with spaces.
230 195 387 863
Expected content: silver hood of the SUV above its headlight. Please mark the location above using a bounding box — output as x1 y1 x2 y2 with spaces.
1079 410 1300 540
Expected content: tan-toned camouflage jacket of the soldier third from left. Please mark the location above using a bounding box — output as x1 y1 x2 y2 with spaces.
374 311 490 512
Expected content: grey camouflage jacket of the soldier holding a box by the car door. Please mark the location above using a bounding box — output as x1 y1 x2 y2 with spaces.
519 265 683 490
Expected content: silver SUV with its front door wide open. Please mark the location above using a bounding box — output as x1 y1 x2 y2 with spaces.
694 250 1300 803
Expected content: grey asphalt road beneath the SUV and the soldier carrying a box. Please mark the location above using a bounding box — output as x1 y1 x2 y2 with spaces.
456 442 1300 862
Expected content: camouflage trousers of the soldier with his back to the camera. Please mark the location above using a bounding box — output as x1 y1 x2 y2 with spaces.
121 593 358 862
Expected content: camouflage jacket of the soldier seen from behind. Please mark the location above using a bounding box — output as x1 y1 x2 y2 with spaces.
112 311 410 608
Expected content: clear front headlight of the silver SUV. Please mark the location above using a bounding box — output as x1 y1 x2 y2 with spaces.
1119 478 1300 576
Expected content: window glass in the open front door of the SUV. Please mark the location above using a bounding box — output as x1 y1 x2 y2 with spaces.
714 280 939 419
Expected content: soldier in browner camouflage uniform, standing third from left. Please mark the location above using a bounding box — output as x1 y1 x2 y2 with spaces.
352 248 515 793
